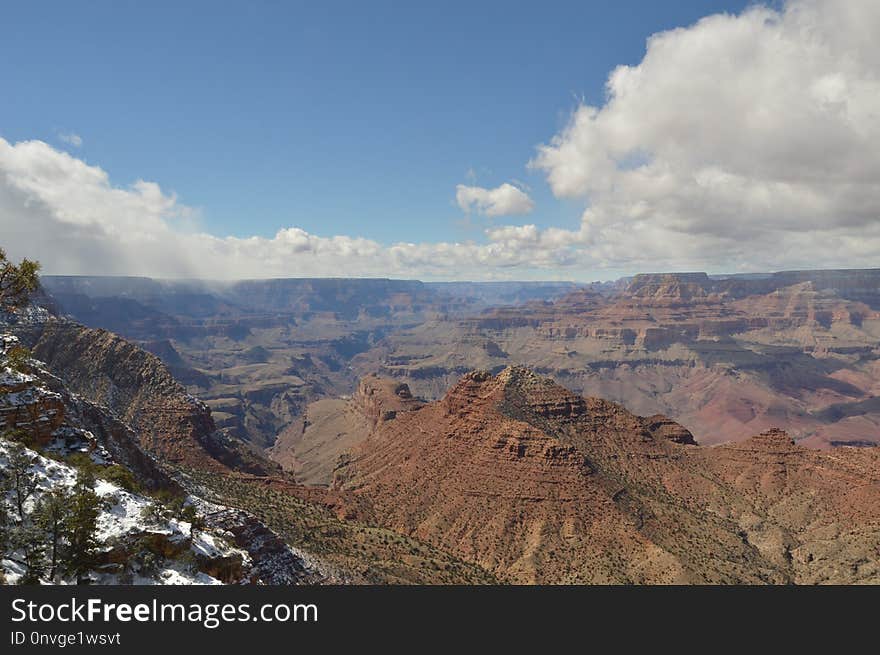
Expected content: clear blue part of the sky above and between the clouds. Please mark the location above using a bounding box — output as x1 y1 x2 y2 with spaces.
0 0 746 244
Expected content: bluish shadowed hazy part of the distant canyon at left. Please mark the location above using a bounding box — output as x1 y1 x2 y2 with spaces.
43 276 576 449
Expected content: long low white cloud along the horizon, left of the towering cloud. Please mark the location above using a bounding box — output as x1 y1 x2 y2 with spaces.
0 138 567 279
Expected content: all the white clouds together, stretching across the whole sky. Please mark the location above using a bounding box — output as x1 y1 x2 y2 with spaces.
0 0 880 279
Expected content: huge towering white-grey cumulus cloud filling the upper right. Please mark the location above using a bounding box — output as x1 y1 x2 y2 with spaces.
530 0 880 270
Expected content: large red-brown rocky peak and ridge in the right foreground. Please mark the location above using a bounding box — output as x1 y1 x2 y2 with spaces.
337 367 880 583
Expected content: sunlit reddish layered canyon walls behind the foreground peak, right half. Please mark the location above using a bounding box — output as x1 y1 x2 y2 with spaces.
352 271 880 448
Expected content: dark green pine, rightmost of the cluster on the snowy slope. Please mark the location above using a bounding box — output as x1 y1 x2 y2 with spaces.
65 471 101 584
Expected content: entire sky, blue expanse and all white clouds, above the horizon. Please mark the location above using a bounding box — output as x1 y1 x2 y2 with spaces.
0 0 880 280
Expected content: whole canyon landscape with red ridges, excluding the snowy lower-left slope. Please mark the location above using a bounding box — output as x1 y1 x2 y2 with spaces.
0 270 880 584
